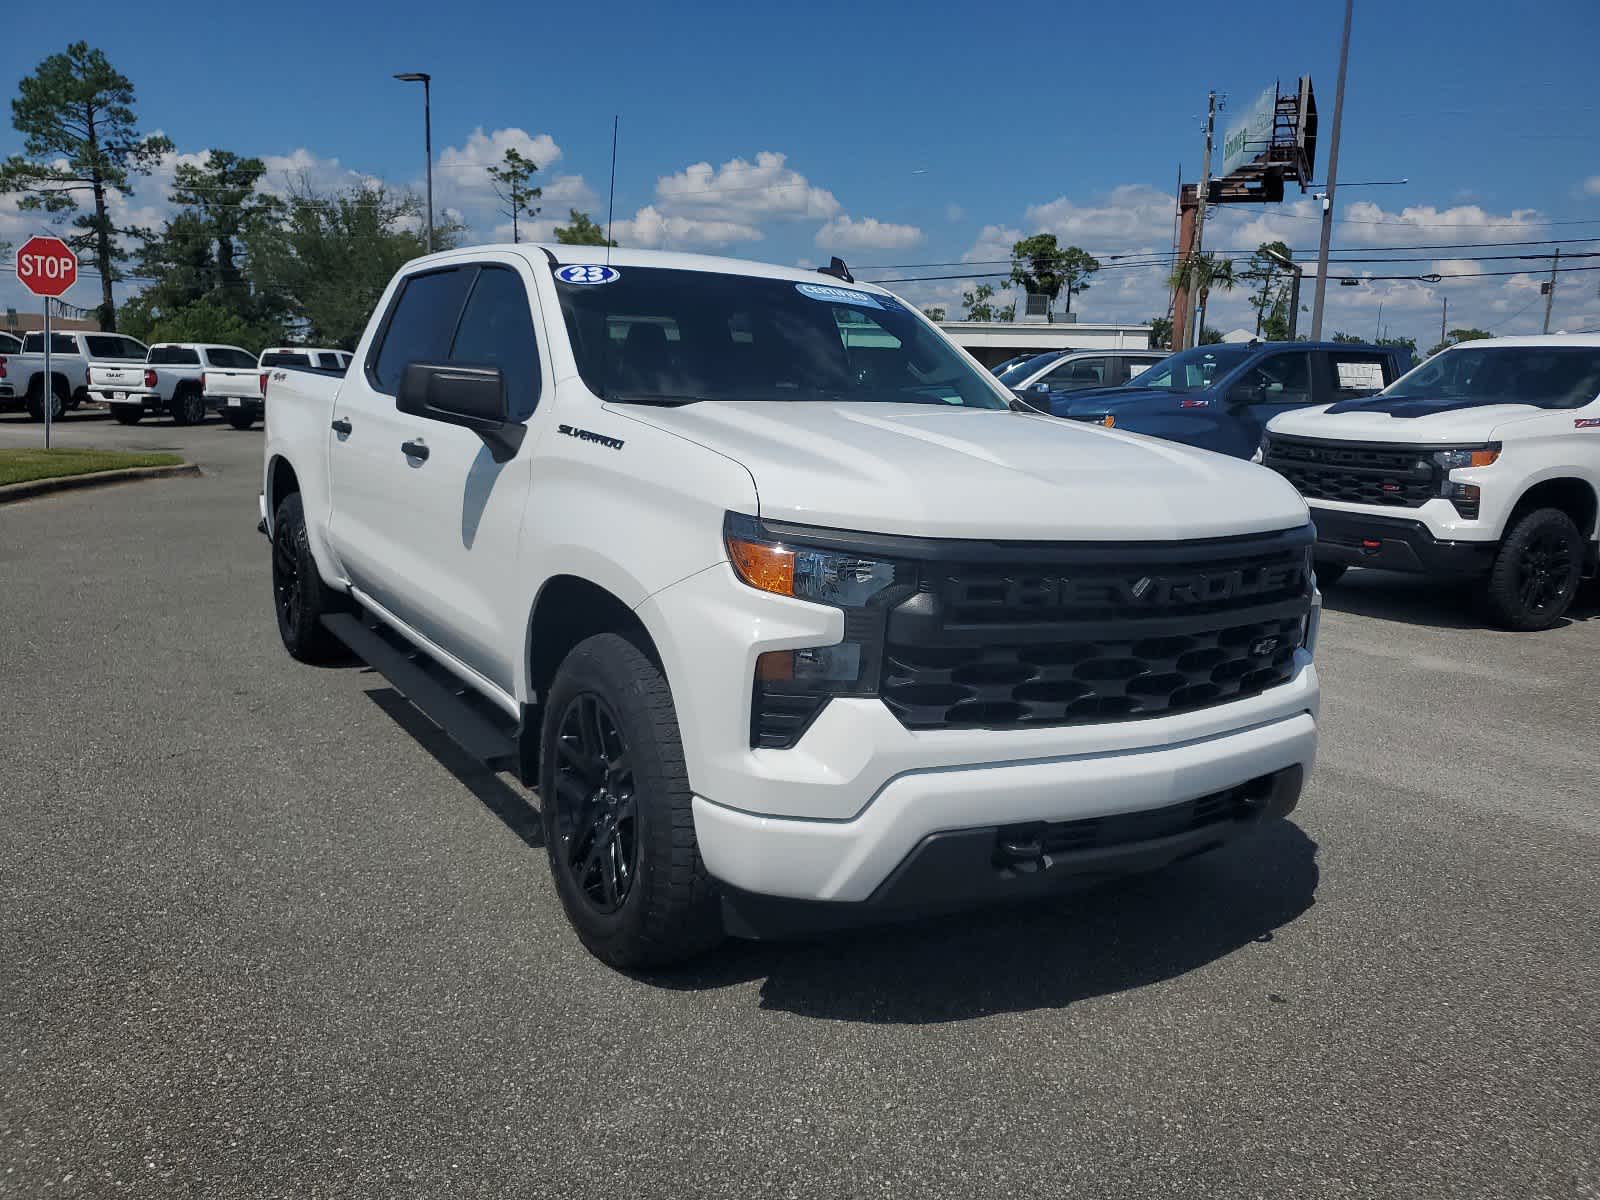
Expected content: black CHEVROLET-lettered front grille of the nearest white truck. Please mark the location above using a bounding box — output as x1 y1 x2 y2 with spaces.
880 526 1312 730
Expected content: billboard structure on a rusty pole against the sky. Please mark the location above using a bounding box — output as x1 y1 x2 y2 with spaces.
1173 75 1317 349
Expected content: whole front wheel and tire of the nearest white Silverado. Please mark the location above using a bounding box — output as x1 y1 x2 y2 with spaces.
539 634 723 968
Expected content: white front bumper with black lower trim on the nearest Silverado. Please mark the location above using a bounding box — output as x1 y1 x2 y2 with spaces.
694 710 1317 912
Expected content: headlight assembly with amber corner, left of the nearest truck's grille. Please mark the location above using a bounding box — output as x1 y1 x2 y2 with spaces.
723 512 915 749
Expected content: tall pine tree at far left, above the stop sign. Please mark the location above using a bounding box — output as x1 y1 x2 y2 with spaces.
0 42 173 330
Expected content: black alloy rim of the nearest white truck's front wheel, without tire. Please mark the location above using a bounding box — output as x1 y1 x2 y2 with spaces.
555 691 638 914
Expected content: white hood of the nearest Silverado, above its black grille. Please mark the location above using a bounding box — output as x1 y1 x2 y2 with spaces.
608 402 1307 541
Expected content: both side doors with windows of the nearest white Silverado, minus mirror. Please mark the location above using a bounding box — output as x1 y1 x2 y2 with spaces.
328 258 549 693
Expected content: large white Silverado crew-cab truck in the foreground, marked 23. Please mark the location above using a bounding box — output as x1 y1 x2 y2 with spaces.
261 245 1320 965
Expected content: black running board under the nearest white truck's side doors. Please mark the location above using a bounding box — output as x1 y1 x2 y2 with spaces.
322 613 518 771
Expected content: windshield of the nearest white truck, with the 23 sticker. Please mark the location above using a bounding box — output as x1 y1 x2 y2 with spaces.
555 267 1006 408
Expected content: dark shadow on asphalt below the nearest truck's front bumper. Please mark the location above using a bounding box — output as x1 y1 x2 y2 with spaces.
642 821 1318 1024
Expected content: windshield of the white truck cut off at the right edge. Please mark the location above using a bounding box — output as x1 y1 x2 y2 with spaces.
1374 346 1600 408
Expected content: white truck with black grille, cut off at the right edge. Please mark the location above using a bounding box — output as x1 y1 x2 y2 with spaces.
1261 334 1600 629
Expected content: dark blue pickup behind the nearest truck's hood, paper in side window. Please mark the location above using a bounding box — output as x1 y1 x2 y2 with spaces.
1034 342 1411 458
